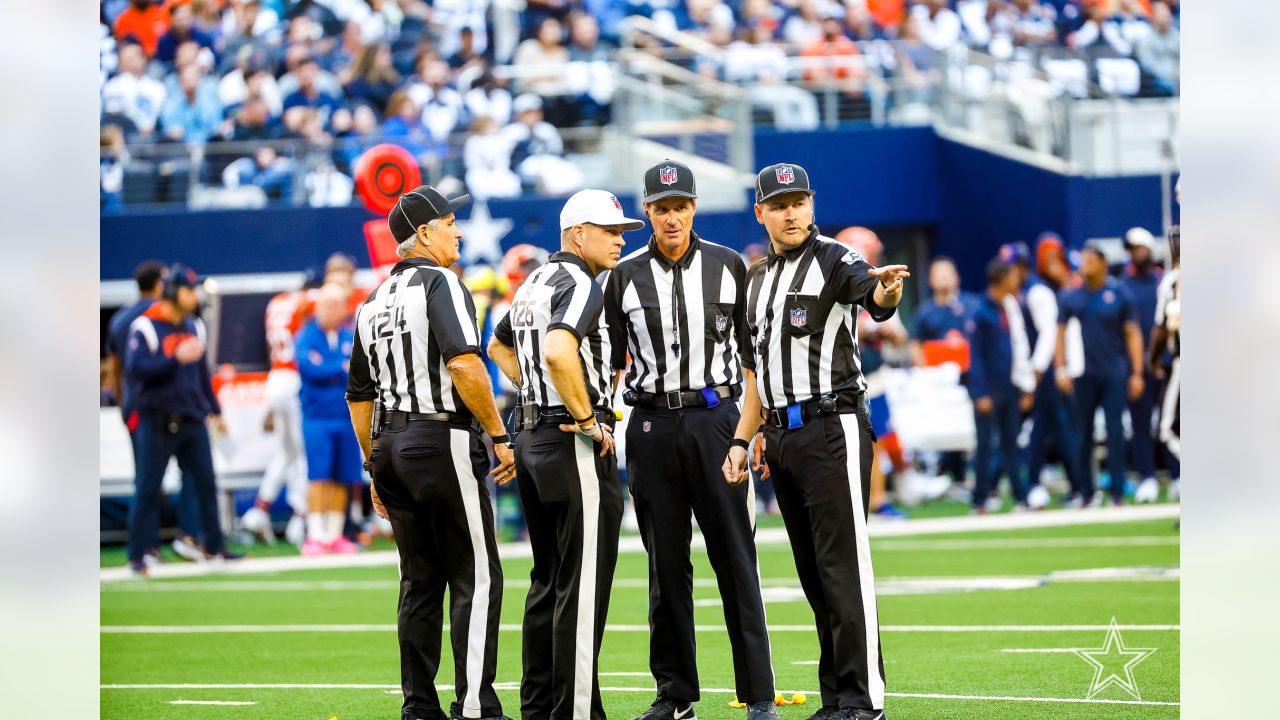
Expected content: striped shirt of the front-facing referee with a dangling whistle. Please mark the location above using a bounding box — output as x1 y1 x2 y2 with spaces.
604 233 753 393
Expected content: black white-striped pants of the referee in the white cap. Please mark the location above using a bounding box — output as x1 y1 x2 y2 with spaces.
516 421 622 720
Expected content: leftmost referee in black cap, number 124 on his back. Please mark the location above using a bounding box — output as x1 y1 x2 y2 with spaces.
347 184 515 720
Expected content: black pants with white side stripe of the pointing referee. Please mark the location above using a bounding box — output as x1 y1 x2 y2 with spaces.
764 411 884 710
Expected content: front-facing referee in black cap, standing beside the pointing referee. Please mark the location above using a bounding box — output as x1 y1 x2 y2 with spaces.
604 160 777 720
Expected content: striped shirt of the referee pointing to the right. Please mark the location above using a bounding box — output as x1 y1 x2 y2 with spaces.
746 229 895 410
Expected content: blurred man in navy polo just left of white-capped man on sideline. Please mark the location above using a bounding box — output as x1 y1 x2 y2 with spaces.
1053 243 1144 506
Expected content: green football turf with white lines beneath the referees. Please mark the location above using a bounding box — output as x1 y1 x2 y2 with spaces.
101 511 1180 720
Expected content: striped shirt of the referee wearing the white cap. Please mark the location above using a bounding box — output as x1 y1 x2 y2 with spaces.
494 252 613 407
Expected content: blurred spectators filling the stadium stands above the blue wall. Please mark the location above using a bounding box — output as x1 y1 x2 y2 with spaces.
100 0 1179 210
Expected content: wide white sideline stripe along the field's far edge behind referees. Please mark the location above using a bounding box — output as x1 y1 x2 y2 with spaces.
99 505 1180 583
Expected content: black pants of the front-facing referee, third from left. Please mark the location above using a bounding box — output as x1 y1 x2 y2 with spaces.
627 401 773 705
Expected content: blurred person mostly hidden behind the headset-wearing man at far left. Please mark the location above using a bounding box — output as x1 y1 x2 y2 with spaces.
106 260 204 564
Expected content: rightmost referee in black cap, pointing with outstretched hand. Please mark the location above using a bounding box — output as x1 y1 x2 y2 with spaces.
723 163 910 720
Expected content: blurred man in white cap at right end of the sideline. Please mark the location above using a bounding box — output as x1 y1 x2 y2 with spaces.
1120 228 1164 502
